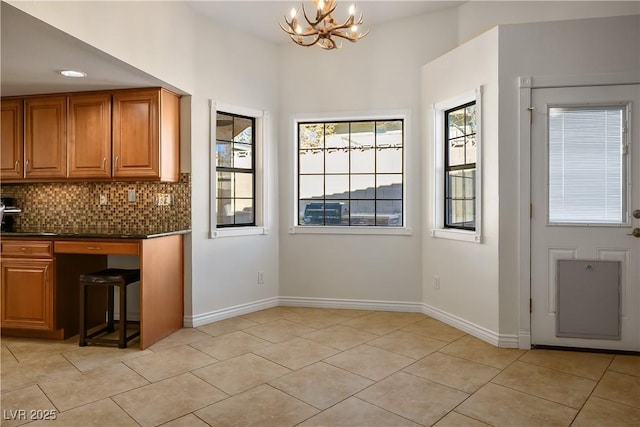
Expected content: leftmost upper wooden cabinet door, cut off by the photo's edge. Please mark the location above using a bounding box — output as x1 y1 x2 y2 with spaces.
0 99 24 182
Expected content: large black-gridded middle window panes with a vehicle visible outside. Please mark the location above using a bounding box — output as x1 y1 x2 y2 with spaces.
295 117 405 228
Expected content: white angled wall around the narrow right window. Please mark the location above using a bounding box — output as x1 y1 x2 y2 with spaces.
422 28 499 338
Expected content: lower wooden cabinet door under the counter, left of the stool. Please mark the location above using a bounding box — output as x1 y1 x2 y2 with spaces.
0 258 54 330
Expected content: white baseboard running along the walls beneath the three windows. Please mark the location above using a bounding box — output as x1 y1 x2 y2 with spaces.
184 297 523 348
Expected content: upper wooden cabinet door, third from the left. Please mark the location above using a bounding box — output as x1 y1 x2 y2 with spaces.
68 94 111 178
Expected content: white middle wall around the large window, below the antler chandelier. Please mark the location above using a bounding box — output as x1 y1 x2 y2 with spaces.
279 9 458 303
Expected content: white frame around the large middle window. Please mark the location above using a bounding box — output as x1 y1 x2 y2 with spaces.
289 109 417 236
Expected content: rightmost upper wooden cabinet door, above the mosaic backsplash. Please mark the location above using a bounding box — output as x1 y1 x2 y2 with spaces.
113 89 160 179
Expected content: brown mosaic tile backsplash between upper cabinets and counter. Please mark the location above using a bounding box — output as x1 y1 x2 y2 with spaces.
0 174 191 231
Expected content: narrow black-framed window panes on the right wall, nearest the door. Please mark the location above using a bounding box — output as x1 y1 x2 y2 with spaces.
444 101 477 231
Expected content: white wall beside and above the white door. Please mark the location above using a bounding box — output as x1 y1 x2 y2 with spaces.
499 15 640 340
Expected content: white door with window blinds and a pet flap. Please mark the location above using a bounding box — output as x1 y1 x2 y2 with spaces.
531 85 640 351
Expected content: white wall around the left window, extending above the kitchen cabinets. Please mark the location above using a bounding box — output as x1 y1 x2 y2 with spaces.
11 2 279 323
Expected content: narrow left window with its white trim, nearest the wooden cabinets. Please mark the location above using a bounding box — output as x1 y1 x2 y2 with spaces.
211 101 267 237
